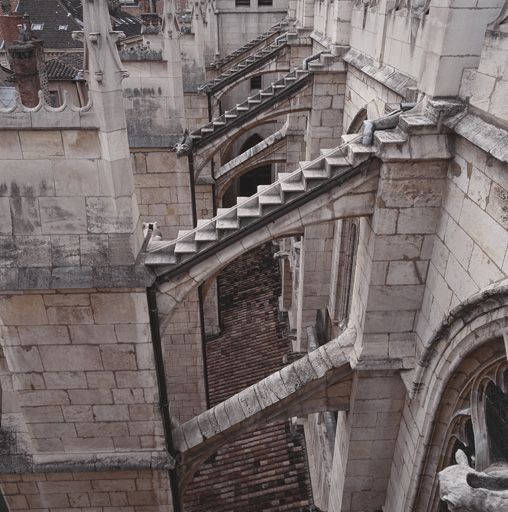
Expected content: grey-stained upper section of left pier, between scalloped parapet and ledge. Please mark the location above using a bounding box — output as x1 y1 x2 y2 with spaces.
0 129 140 289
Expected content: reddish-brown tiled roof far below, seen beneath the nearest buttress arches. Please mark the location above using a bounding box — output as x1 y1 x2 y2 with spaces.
184 244 311 512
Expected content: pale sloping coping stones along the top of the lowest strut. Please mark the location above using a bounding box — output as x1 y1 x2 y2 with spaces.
173 328 356 453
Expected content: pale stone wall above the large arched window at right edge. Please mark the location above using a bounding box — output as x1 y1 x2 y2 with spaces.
417 138 508 358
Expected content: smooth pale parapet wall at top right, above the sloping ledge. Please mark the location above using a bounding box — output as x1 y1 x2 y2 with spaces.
350 0 503 96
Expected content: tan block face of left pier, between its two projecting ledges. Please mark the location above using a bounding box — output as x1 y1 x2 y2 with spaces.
0 290 164 454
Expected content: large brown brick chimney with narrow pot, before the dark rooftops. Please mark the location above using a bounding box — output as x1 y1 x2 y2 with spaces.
7 14 44 107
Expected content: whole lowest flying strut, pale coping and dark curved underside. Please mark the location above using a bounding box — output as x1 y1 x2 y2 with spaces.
173 328 356 486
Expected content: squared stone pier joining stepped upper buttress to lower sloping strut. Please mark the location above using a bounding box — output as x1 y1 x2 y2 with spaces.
353 136 448 367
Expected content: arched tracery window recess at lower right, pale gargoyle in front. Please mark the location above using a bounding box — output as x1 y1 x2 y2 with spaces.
414 337 508 512
